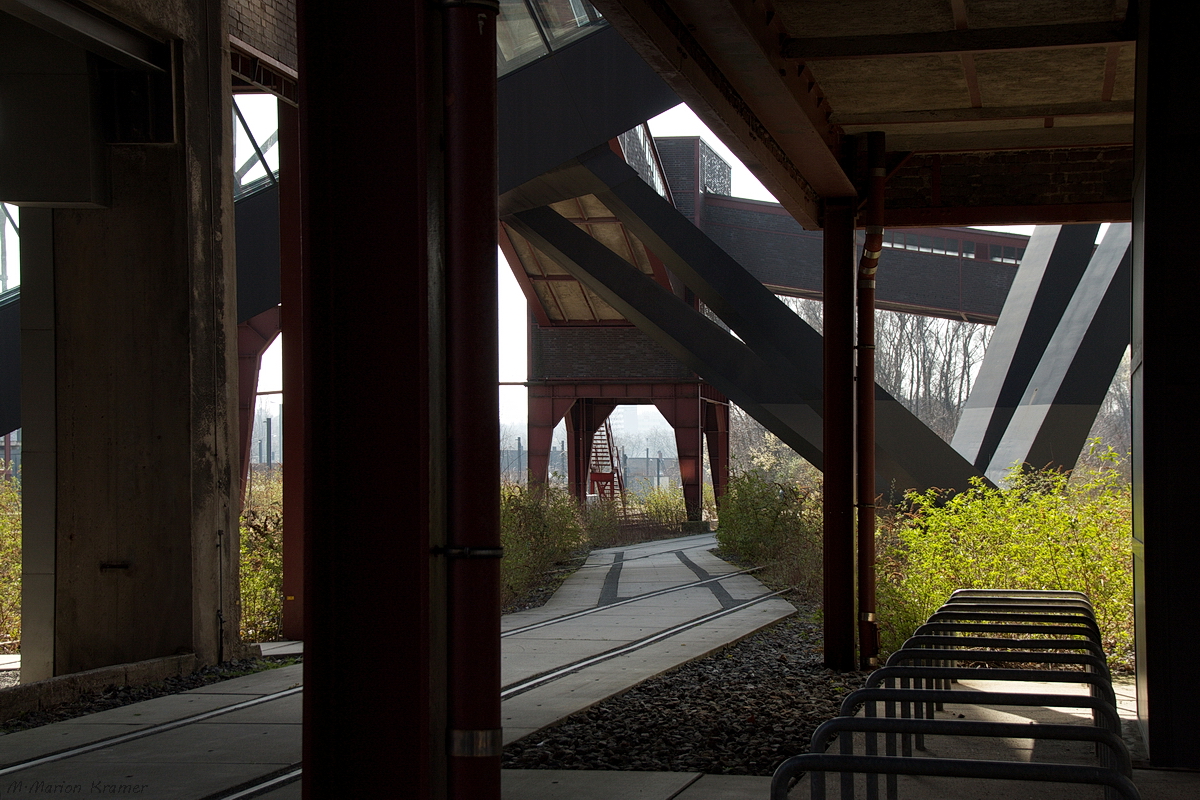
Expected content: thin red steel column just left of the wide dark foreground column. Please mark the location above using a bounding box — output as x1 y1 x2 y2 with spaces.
277 100 308 640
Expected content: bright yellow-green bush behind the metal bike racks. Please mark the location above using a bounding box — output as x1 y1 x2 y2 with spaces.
877 453 1133 666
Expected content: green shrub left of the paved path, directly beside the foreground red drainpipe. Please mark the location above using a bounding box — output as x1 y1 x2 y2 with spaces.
500 483 586 604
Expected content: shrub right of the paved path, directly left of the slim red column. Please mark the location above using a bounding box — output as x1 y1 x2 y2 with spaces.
716 470 822 600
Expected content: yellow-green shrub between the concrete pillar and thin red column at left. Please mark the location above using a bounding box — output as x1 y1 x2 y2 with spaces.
241 468 283 642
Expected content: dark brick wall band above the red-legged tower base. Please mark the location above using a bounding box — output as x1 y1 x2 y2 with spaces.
529 325 696 381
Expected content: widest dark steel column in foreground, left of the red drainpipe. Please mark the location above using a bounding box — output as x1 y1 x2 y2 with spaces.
300 0 446 800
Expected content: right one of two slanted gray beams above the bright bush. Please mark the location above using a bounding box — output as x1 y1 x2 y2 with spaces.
988 222 1133 481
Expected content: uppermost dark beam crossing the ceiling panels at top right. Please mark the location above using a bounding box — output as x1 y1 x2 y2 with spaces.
781 20 1136 61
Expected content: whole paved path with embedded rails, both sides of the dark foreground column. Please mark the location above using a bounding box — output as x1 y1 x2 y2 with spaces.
0 536 791 800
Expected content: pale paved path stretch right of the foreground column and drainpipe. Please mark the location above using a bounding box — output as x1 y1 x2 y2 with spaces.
500 534 796 744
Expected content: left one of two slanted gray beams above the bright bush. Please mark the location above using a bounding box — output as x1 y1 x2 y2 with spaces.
952 224 1112 470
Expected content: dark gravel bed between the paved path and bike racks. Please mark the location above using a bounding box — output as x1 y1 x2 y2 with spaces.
504 608 868 775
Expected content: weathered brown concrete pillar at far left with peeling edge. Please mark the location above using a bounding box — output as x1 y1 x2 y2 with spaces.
17 0 239 680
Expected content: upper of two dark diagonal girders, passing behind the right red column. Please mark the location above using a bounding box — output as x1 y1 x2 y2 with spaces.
580 144 978 488
